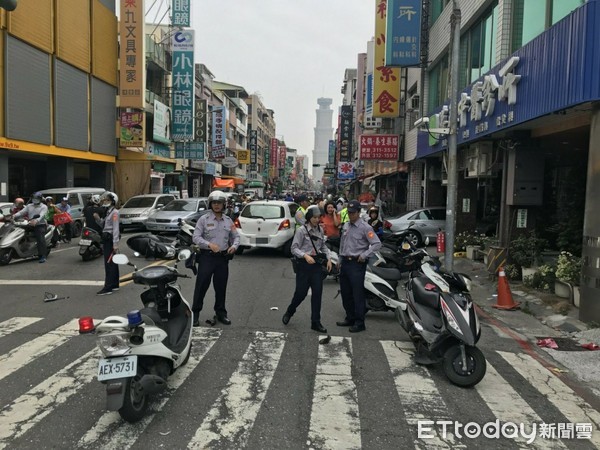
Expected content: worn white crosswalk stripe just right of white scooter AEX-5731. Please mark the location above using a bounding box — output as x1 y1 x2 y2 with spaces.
77 328 222 450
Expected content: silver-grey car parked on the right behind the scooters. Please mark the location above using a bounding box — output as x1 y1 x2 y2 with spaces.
386 206 446 246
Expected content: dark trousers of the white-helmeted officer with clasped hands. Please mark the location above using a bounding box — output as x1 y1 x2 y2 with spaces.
192 251 229 317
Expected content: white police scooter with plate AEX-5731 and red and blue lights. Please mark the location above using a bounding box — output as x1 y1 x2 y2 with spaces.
79 249 193 422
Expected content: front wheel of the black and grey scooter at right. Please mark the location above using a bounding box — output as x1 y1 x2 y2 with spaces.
443 345 487 387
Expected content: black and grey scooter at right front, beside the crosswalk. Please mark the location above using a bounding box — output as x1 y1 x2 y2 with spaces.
396 248 487 387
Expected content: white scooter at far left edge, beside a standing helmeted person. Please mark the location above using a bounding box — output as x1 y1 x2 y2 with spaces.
0 216 54 266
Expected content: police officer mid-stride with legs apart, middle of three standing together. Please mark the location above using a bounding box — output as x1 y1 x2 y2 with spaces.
281 205 332 333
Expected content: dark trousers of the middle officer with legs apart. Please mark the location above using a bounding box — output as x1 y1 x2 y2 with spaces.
287 260 323 324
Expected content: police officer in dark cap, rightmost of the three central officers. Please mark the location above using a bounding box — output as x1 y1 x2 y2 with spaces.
336 200 381 333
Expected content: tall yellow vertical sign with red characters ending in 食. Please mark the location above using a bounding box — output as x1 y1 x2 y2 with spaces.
373 0 400 117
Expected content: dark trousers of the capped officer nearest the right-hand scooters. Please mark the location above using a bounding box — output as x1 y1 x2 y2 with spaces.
340 257 367 326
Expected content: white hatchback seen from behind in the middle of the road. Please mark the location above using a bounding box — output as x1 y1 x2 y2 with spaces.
235 200 299 256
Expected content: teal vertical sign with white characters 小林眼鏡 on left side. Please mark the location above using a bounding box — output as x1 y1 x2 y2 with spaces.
171 30 194 141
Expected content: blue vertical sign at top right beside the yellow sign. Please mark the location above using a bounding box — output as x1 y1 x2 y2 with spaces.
385 0 421 66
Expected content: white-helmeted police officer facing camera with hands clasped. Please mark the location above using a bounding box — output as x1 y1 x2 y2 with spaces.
192 191 240 327
